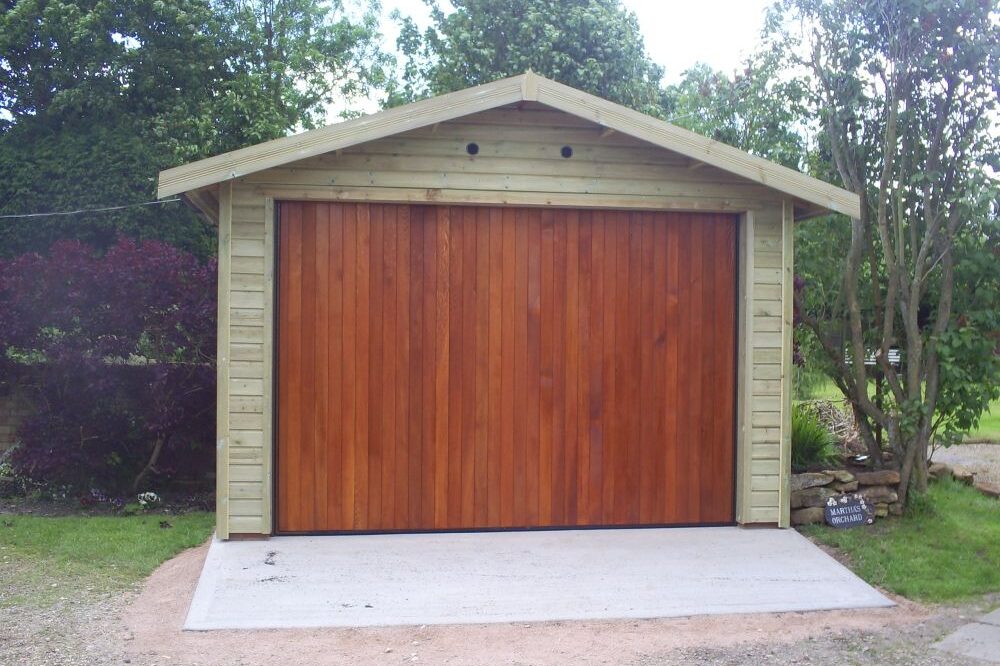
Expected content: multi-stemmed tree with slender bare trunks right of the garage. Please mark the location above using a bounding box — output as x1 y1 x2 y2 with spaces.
771 0 1000 500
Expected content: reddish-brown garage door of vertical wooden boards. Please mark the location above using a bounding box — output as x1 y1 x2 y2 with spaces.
277 203 736 533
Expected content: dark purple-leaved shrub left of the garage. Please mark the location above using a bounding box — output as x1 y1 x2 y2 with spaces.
0 238 216 493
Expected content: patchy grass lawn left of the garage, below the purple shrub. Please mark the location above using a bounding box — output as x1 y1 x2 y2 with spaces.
0 512 214 608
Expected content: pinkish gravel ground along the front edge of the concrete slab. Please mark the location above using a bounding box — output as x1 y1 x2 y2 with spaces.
0 547 1000 666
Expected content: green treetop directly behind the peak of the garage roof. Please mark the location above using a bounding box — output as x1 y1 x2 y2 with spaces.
389 0 663 115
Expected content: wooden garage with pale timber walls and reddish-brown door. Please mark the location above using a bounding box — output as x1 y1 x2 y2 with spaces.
160 74 858 538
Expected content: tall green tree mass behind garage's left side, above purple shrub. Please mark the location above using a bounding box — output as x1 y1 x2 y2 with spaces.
0 0 384 256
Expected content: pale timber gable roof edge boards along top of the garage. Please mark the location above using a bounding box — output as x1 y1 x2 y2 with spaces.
157 72 861 217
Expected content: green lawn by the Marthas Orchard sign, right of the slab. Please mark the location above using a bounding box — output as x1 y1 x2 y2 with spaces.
802 481 1000 602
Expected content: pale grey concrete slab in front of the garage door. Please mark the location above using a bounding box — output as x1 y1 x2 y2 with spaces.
185 527 893 630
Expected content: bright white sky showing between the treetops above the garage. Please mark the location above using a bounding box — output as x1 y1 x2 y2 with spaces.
382 0 773 83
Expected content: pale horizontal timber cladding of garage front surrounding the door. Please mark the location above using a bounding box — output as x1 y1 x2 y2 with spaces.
217 110 791 538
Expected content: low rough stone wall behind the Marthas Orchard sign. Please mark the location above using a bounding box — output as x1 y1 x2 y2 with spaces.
789 469 903 525
